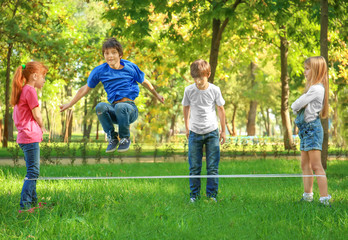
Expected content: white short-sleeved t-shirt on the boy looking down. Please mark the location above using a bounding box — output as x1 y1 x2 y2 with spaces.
182 83 225 134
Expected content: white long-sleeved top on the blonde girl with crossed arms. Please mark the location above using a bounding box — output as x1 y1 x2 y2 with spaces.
291 83 325 122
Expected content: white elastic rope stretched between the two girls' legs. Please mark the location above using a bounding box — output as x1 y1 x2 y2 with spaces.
25 174 326 181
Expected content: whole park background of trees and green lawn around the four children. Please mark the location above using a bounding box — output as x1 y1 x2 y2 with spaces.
0 0 348 239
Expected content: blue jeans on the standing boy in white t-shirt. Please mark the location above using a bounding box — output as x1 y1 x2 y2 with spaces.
188 129 220 198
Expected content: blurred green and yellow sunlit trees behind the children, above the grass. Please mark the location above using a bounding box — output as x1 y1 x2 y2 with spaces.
0 0 348 156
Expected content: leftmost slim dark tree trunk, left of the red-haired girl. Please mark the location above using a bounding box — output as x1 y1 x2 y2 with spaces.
2 42 13 148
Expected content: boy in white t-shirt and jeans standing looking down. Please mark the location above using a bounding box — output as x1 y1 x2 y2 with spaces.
182 59 226 202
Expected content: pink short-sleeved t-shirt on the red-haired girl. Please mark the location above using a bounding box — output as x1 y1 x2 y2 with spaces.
13 85 42 144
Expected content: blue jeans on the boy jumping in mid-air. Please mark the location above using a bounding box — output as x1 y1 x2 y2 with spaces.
95 102 138 138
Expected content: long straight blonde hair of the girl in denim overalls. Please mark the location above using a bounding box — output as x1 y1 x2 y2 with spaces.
304 56 329 118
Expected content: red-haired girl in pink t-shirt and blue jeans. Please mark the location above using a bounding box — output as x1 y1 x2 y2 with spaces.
11 62 48 212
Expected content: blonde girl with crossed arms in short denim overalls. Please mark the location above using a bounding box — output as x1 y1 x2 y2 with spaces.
291 56 331 205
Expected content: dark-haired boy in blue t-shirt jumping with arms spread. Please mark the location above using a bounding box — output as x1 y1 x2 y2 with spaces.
60 38 164 152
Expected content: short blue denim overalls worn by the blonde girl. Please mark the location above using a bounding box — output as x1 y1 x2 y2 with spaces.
295 111 324 152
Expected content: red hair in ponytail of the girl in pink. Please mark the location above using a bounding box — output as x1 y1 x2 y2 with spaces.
10 62 48 106
